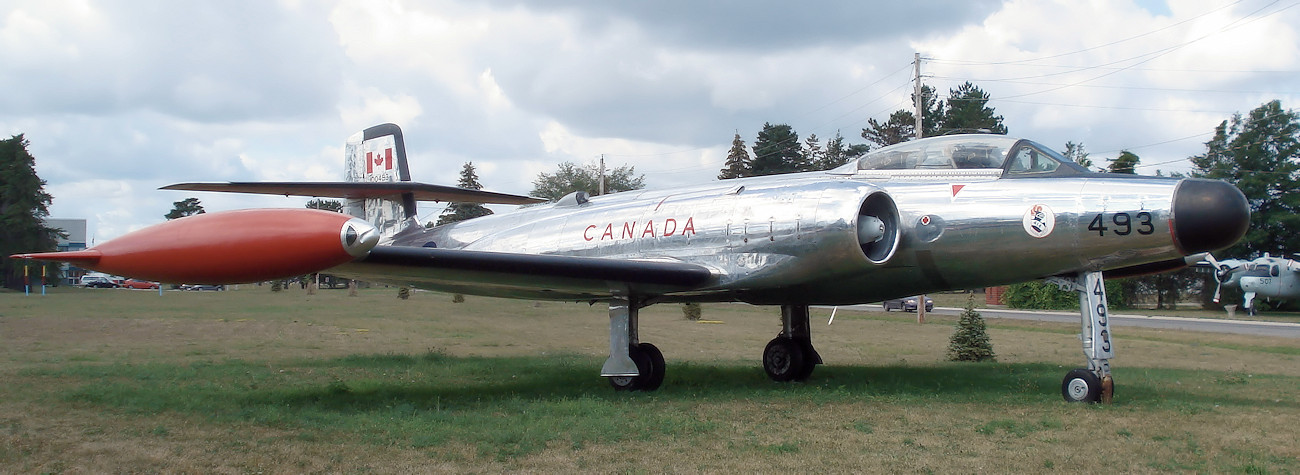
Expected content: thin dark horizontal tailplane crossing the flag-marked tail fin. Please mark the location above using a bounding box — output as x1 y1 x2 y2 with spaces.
161 181 546 204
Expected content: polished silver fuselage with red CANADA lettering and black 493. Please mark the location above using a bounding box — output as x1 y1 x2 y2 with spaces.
384 169 1183 305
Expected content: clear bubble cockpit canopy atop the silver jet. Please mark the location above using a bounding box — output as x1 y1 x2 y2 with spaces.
832 134 1088 177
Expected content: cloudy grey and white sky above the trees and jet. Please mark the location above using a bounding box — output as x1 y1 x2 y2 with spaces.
0 0 1300 242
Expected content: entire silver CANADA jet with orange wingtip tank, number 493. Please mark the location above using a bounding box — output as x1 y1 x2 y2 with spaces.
14 124 1249 402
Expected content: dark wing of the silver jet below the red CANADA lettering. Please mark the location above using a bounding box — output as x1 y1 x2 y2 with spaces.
324 246 716 299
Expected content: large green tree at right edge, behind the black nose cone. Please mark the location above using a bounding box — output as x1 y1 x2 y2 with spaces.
1192 100 1300 256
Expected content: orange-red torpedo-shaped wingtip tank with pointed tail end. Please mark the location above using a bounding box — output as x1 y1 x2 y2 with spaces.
12 210 380 284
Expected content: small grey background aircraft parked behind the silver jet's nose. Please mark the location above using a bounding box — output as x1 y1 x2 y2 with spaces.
1205 252 1300 315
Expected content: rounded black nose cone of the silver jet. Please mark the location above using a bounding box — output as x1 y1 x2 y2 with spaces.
1173 178 1251 255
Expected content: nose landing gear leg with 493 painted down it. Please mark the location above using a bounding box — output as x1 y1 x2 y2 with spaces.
1048 272 1115 403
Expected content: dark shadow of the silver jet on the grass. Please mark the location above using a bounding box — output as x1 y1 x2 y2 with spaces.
246 355 1300 411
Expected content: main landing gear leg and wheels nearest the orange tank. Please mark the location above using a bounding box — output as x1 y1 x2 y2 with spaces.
601 298 664 390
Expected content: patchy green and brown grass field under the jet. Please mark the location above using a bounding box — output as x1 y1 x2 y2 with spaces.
0 286 1300 474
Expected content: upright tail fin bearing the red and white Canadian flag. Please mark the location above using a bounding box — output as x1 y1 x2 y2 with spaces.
343 124 419 238
